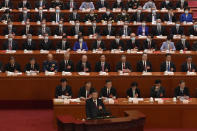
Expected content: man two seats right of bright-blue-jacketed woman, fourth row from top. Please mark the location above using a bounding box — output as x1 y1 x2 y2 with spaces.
110 34 124 50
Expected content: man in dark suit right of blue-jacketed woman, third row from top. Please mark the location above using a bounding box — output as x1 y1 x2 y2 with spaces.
152 19 166 36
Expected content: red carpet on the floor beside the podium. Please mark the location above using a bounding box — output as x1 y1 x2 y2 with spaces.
0 109 197 131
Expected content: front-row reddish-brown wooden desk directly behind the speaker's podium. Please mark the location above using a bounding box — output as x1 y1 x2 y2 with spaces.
53 98 197 128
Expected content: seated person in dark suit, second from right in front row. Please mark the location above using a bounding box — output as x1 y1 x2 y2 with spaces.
150 80 165 98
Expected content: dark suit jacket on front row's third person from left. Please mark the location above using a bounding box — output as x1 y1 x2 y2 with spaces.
100 87 117 98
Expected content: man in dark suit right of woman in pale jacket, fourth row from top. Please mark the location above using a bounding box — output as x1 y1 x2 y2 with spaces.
176 35 191 51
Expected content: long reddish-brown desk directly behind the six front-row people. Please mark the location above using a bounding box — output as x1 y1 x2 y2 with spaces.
0 72 197 101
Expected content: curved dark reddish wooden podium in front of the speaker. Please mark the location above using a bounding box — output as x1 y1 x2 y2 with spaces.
57 110 146 131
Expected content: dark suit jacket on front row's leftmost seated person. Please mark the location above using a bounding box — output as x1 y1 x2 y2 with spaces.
55 85 72 98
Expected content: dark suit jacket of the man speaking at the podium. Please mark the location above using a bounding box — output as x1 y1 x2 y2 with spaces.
86 98 107 119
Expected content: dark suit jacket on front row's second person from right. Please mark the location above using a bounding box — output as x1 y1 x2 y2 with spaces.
150 86 165 98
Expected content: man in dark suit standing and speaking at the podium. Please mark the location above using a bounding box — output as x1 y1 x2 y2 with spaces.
86 91 109 119
